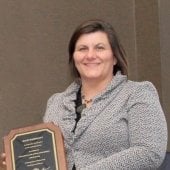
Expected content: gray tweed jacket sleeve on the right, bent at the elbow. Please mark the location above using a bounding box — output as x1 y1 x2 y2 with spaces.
81 82 167 170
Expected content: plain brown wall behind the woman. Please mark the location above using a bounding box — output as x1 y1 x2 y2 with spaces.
0 0 170 169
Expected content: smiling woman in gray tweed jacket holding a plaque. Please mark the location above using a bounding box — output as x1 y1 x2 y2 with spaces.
0 20 167 170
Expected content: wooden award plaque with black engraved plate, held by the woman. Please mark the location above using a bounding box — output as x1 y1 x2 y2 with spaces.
4 123 67 170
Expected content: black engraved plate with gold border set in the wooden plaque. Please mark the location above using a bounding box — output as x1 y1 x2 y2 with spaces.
11 130 58 170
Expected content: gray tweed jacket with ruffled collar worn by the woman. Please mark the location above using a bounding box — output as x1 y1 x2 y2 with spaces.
44 72 167 170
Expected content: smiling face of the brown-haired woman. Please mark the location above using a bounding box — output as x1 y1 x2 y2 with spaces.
73 31 117 81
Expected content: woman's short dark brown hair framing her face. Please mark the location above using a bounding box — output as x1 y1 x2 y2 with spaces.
68 20 128 77
